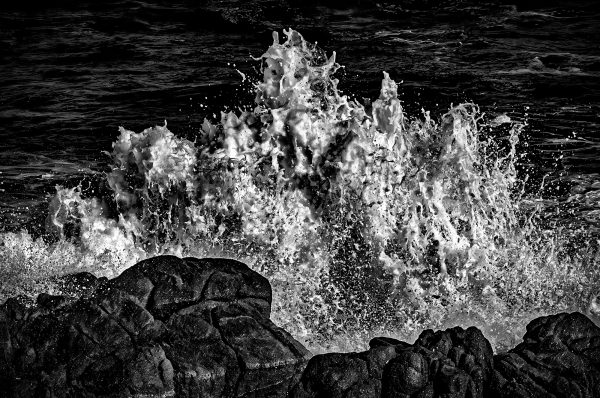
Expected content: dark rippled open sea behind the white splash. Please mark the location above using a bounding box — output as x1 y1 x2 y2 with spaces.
0 0 600 229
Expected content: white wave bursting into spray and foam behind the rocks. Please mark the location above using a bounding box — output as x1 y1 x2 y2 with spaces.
0 30 599 351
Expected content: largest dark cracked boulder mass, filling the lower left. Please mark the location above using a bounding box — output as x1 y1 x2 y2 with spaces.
0 256 309 397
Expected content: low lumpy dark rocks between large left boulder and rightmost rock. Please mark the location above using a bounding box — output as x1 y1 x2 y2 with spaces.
292 327 493 398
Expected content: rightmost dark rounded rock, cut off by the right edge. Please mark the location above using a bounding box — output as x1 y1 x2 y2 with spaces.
494 312 600 398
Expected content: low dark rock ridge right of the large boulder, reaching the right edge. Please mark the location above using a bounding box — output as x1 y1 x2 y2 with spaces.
291 313 600 398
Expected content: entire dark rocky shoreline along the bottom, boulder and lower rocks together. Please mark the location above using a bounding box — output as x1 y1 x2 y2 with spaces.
0 256 600 398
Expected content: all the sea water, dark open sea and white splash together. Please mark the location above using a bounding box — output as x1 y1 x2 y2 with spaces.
0 0 600 351
